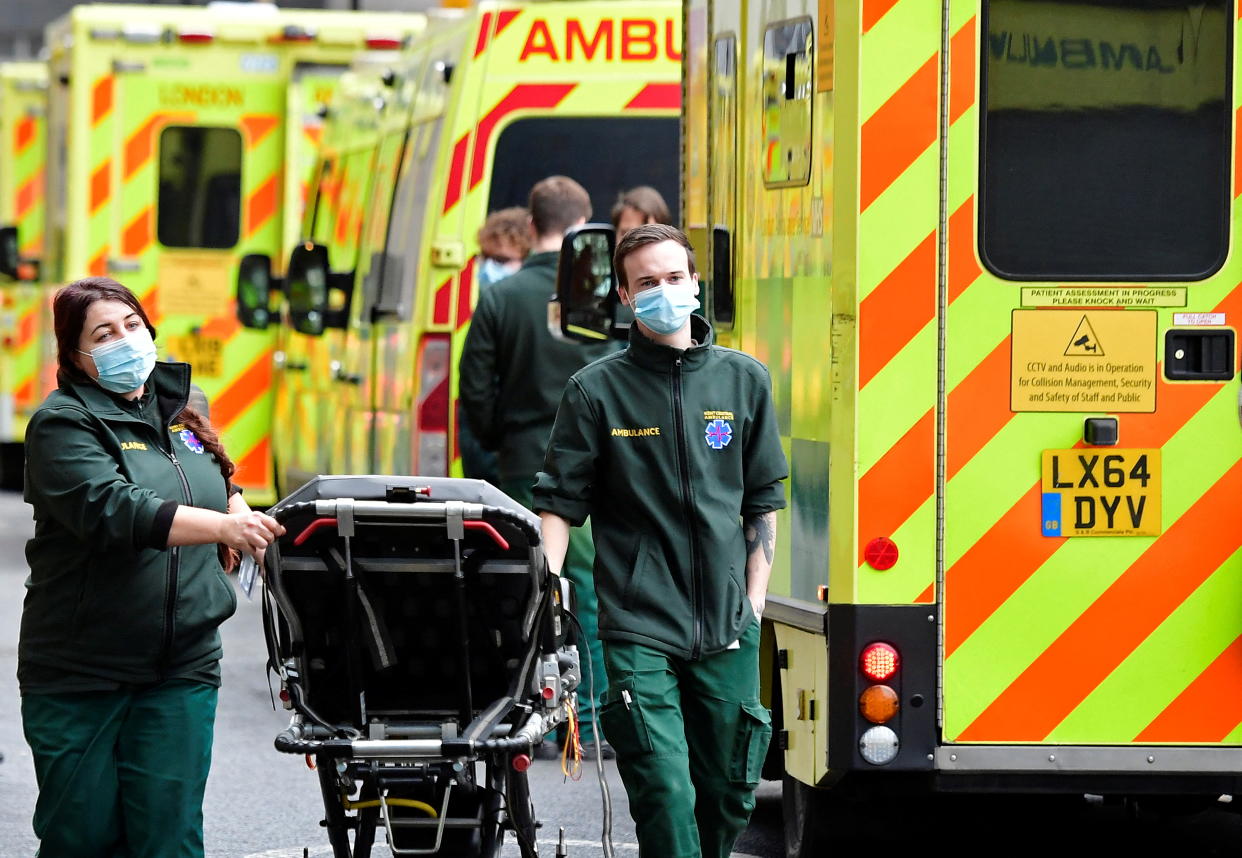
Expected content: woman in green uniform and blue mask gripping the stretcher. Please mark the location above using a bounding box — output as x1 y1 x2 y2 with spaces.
17 277 283 858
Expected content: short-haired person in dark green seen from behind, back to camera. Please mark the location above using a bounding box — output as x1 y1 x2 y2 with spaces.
458 176 615 754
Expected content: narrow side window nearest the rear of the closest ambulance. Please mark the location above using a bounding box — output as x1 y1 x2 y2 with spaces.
761 19 815 187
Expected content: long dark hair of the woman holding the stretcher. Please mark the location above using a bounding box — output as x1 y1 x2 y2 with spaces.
52 277 237 571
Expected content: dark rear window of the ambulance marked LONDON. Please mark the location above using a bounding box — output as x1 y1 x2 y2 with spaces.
155 125 242 248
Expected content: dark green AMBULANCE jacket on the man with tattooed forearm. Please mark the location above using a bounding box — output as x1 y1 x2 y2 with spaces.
534 315 789 659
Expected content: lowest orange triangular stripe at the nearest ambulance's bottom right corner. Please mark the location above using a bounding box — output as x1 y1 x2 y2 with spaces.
1134 636 1242 743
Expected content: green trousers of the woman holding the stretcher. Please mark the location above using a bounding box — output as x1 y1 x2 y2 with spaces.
21 680 217 858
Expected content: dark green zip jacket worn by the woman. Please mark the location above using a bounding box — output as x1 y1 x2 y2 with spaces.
17 363 237 693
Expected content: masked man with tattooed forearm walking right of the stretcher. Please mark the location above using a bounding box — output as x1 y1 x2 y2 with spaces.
534 224 787 858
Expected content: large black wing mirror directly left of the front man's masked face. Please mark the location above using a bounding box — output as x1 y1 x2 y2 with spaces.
548 224 628 343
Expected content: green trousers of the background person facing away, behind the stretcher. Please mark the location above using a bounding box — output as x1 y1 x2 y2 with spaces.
501 477 609 746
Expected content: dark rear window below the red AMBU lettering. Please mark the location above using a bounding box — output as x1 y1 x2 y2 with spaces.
487 117 681 229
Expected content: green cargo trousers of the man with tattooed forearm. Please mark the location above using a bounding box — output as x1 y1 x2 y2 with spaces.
602 622 771 858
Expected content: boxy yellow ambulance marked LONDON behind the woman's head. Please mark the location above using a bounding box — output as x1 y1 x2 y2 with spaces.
46 2 425 504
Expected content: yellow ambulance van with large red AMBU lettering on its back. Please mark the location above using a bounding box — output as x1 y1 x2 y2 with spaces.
238 0 682 496
